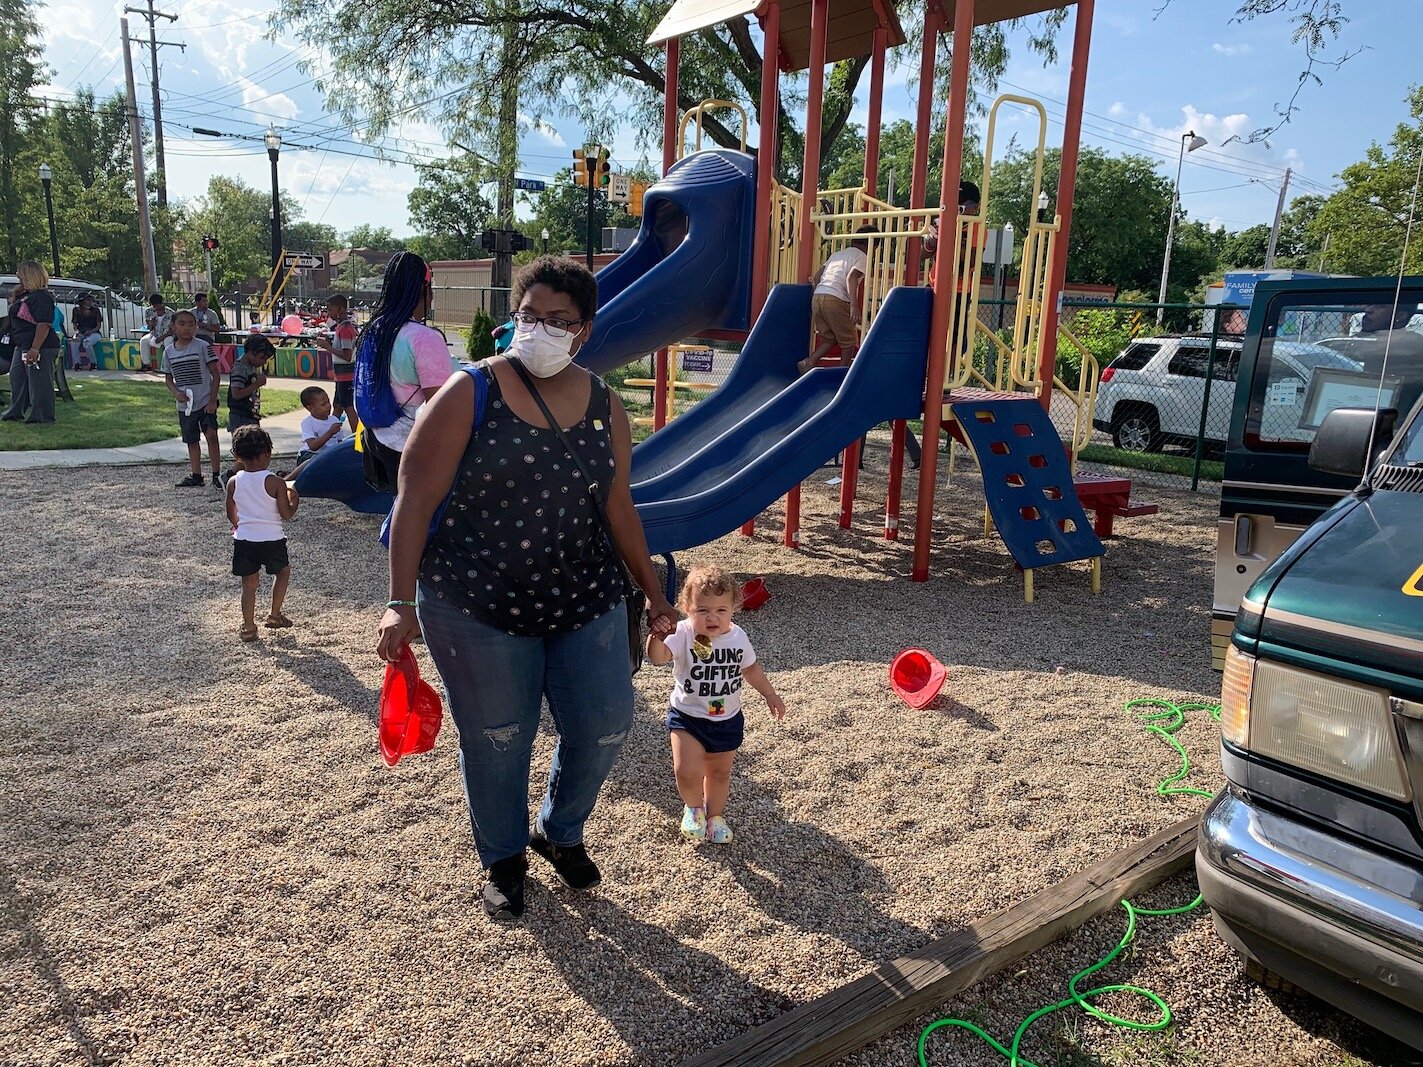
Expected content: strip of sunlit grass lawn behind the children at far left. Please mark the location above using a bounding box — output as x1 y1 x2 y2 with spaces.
0 376 300 452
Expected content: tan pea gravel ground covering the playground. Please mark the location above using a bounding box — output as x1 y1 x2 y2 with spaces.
0 452 1411 1067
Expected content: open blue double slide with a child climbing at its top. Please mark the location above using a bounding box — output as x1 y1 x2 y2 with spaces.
632 286 932 555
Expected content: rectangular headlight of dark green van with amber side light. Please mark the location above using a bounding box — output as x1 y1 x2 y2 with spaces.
1252 659 1410 801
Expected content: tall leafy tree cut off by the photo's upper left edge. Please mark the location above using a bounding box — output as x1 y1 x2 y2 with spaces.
0 0 50 270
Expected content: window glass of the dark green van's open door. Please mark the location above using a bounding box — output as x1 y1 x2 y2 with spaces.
1245 289 1423 458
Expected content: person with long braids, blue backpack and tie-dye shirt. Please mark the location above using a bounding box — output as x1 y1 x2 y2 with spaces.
356 252 455 489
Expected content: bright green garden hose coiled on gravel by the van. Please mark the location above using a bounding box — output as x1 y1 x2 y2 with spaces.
919 697 1221 1067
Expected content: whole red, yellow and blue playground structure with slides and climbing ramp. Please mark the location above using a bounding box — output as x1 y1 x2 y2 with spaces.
299 0 1140 599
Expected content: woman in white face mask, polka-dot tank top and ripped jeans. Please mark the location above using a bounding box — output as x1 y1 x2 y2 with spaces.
378 258 677 919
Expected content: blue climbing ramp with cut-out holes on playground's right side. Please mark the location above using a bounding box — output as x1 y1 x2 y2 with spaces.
949 397 1106 570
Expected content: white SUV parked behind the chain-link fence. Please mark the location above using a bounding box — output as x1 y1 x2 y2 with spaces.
1091 334 1360 452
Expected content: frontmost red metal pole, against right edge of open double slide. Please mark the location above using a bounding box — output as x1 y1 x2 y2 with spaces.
909 0 973 582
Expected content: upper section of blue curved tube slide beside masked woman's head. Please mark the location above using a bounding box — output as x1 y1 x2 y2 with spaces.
578 148 756 374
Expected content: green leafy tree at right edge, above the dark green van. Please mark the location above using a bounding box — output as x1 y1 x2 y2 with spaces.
1305 85 1423 275
